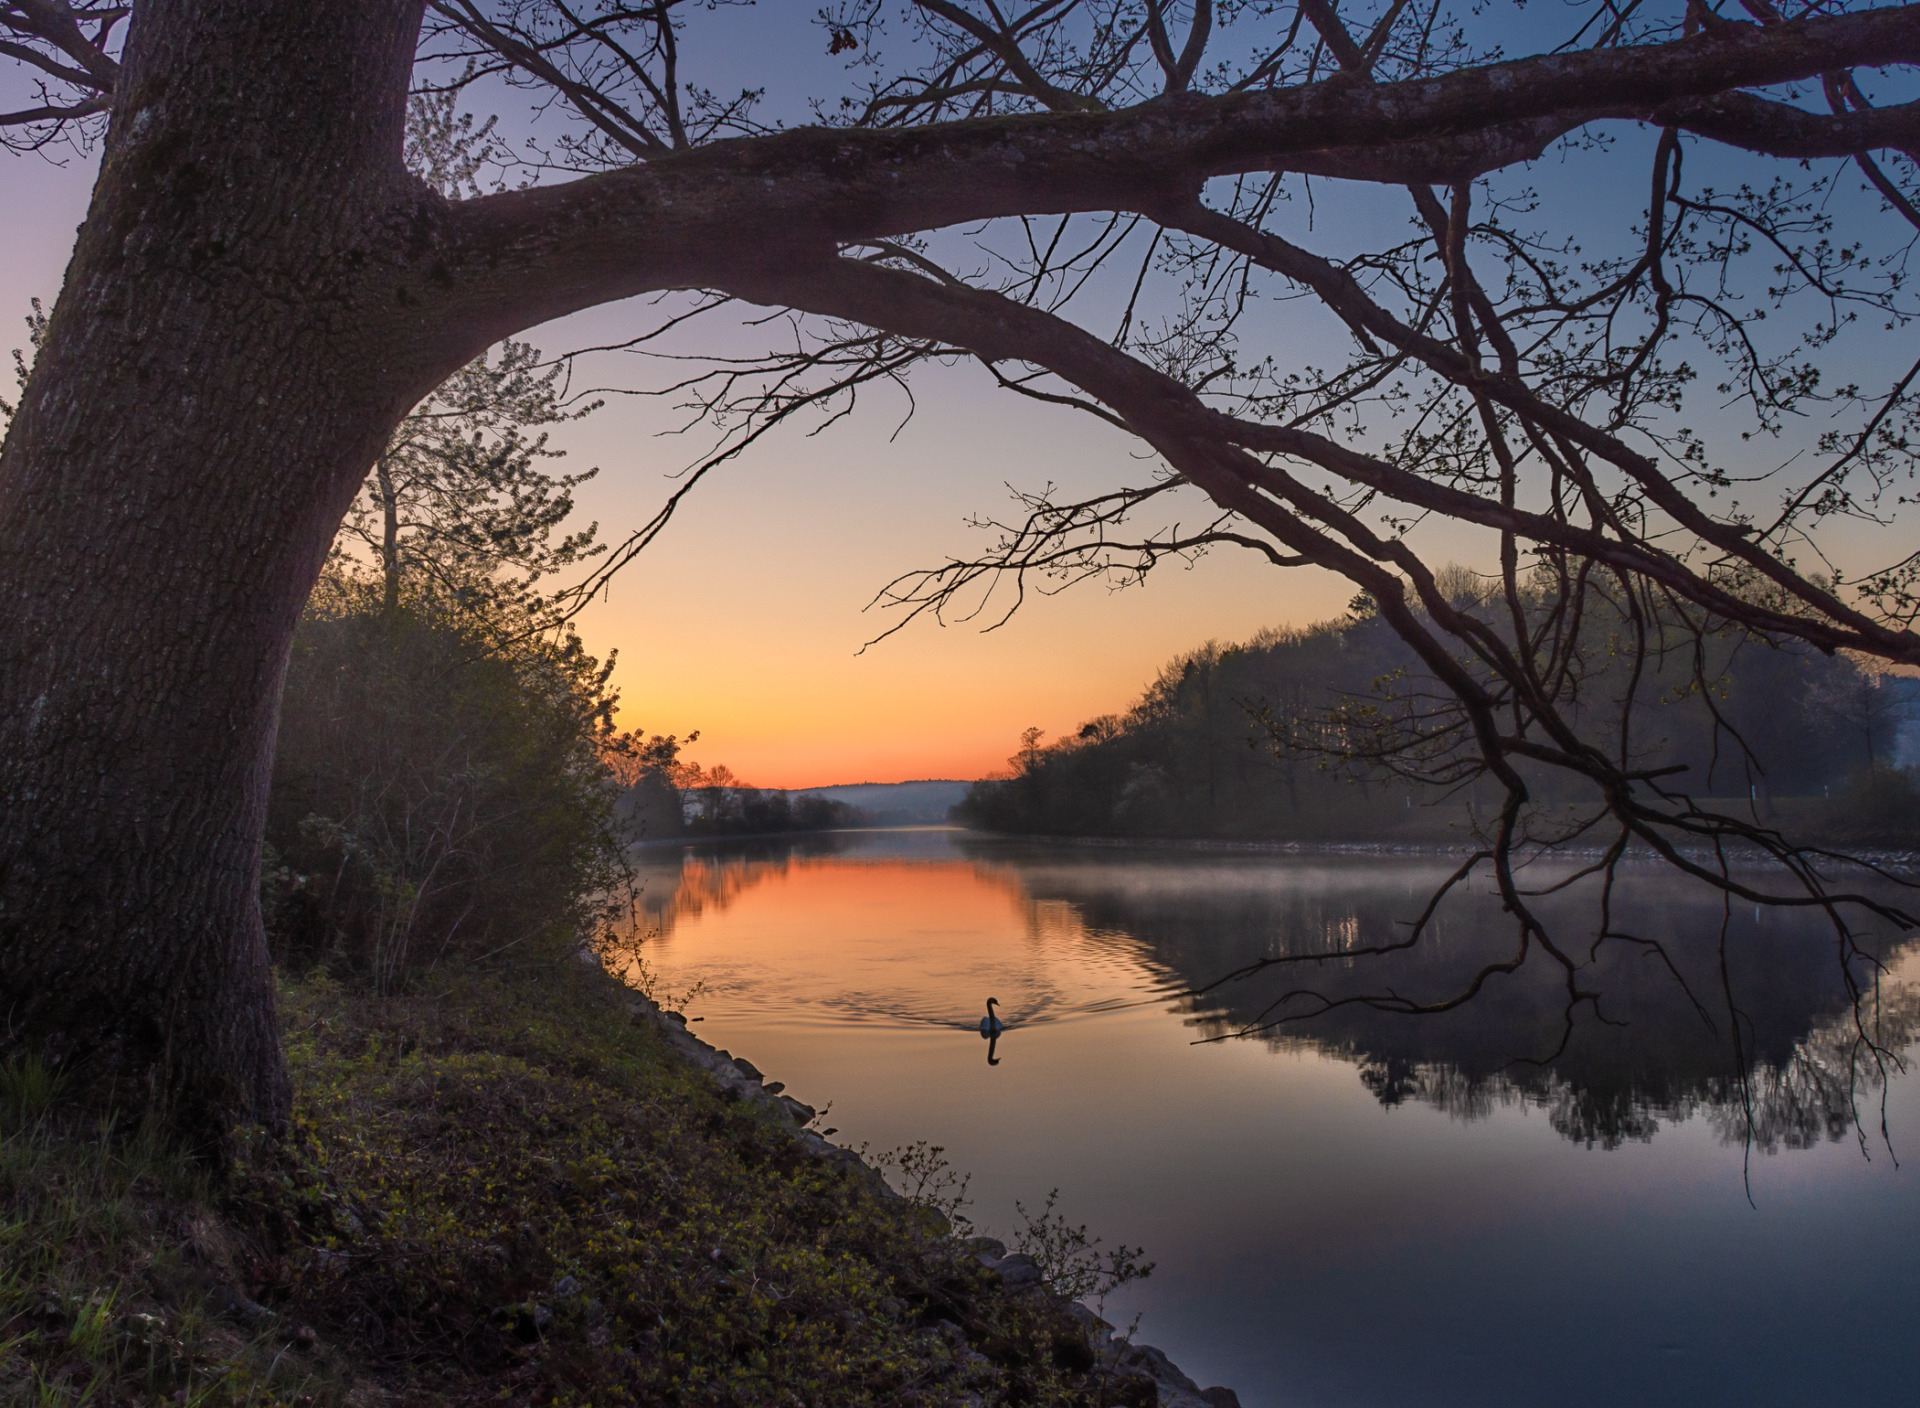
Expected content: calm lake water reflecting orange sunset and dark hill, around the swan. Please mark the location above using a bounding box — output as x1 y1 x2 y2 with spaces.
622 830 1920 1408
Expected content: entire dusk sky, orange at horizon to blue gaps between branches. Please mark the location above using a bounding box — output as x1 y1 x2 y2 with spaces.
0 0 1912 788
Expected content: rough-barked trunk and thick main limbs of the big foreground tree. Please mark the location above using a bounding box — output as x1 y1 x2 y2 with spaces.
0 0 1920 1135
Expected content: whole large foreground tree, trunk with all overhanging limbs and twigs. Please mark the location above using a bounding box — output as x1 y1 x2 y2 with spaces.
0 0 1920 1131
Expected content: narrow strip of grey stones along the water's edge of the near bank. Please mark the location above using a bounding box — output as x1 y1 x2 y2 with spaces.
618 983 1240 1408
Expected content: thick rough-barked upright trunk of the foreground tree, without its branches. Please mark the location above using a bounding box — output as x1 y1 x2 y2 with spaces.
0 0 439 1139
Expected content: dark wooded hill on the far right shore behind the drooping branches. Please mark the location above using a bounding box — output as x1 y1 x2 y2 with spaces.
954 567 1920 845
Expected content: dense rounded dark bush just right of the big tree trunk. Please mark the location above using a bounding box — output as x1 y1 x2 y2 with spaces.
267 572 634 991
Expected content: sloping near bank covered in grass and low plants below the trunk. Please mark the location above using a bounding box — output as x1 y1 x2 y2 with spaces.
0 960 1231 1408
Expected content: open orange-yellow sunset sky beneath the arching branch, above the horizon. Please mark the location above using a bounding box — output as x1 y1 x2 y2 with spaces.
560 332 1354 788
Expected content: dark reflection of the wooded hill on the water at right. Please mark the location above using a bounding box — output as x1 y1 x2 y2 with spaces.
960 843 1920 1151
